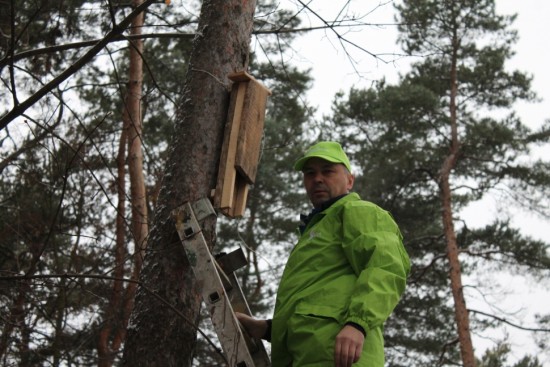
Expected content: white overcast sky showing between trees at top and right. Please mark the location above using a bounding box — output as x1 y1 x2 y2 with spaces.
272 0 550 367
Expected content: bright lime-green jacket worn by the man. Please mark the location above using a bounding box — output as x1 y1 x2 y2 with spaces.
271 193 410 367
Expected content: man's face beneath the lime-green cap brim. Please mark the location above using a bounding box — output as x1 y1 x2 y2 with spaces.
302 158 354 208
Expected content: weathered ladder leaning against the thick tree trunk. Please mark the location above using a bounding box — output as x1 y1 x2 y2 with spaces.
172 198 271 367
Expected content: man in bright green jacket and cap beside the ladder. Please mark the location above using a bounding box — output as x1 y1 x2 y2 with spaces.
237 142 410 367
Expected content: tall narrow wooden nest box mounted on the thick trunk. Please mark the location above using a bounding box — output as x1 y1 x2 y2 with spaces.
213 71 271 218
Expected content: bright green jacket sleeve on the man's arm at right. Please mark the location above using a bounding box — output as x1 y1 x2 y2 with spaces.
342 202 410 333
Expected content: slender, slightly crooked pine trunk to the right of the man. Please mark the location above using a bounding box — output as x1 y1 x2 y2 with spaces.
439 27 475 367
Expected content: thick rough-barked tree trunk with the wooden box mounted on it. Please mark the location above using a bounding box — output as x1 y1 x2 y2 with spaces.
124 0 255 366
